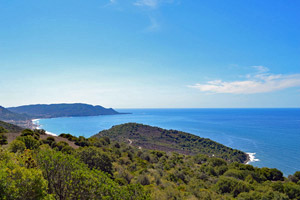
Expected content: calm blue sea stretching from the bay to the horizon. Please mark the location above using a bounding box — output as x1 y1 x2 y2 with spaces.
36 109 300 176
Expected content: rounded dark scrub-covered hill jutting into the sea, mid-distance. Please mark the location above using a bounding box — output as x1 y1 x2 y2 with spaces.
93 123 247 163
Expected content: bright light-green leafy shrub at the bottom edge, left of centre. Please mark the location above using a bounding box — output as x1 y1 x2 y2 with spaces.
37 150 145 200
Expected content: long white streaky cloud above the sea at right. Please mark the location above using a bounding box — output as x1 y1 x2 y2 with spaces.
189 66 300 94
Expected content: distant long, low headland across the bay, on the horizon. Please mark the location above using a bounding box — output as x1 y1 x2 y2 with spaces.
8 103 120 118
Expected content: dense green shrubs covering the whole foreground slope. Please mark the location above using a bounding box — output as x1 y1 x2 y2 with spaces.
0 122 300 200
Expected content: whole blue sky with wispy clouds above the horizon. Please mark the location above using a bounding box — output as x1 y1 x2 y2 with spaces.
0 0 300 108
